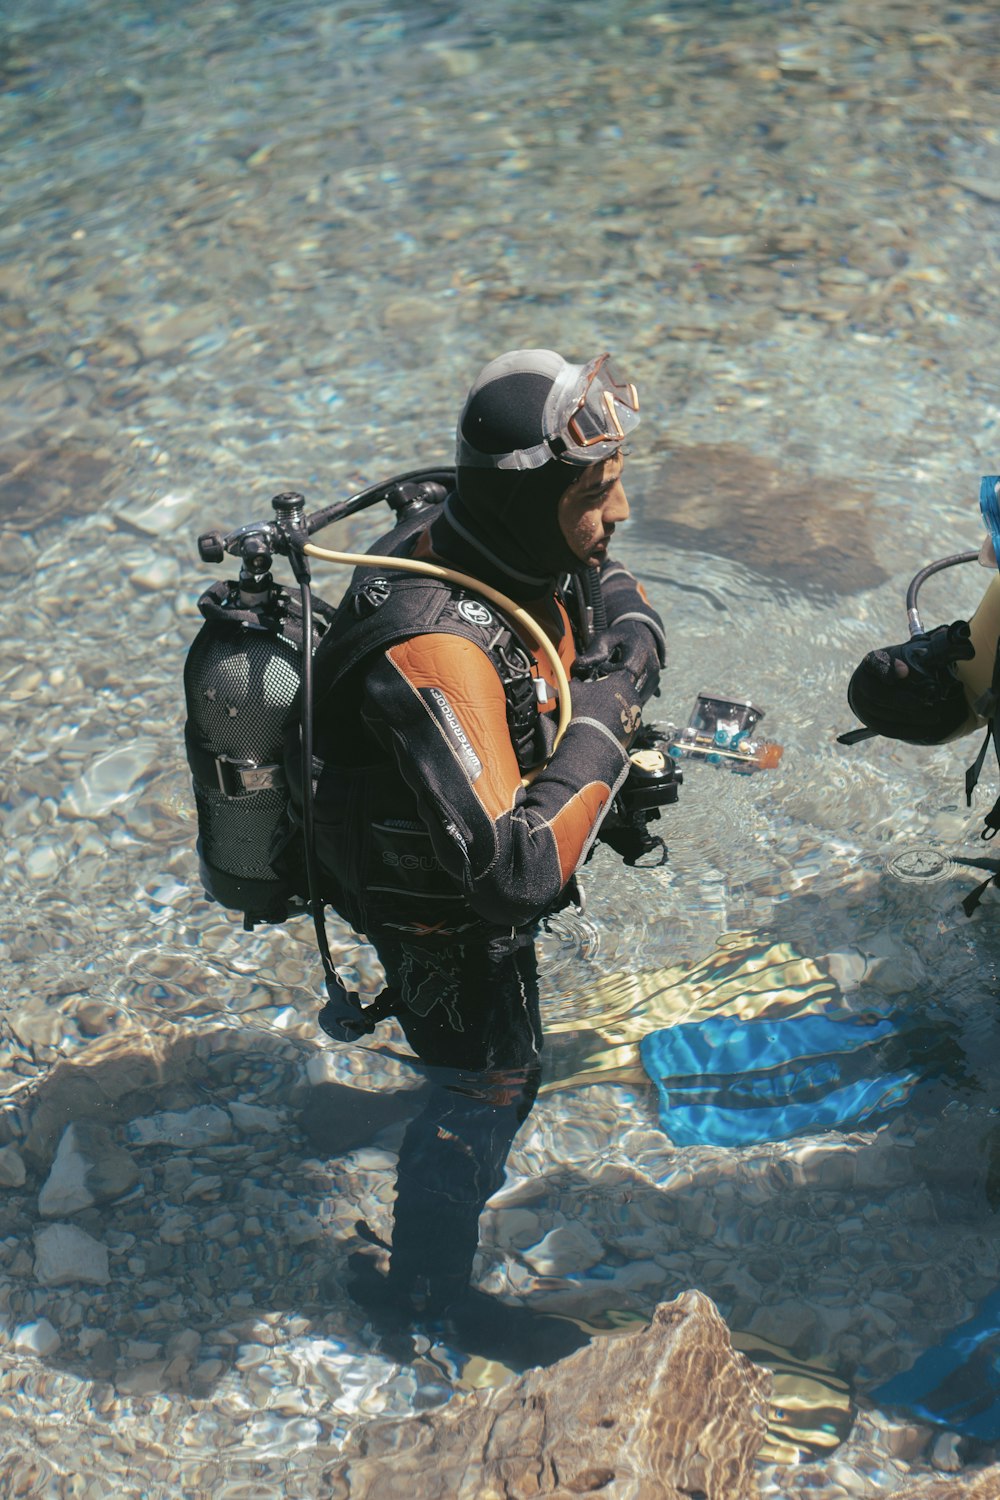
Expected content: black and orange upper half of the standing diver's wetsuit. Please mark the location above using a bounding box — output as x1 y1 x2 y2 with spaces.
308 504 663 939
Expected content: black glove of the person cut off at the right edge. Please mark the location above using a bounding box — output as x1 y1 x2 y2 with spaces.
847 620 976 746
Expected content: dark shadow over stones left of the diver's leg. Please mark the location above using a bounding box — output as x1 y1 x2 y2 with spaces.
0 1020 446 1395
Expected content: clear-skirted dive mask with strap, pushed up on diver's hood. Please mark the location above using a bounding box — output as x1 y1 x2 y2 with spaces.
459 354 639 470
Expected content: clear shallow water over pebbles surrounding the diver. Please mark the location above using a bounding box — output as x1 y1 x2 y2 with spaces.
0 0 1000 1494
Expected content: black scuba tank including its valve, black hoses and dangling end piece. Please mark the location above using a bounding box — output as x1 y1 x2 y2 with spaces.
184 470 453 1041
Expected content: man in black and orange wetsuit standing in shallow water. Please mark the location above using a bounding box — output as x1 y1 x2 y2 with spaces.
186 350 671 1364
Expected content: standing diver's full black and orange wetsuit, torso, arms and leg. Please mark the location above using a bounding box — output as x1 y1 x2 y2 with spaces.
305 510 663 1310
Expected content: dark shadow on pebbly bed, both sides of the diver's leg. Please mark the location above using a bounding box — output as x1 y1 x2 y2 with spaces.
0 876 1000 1434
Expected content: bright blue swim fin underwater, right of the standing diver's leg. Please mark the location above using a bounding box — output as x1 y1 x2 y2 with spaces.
639 1013 919 1146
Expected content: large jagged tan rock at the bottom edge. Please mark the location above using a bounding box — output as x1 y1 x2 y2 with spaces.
324 1292 771 1500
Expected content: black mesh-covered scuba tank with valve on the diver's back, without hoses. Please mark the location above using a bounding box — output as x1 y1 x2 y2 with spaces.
184 495 333 929
